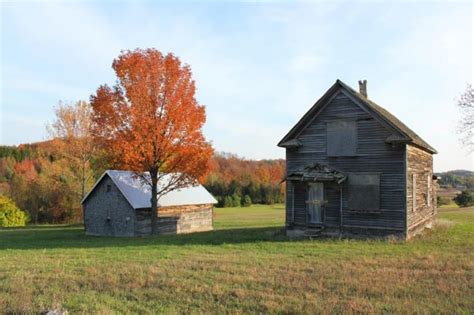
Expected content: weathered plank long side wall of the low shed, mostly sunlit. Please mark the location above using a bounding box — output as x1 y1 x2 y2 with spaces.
135 204 214 235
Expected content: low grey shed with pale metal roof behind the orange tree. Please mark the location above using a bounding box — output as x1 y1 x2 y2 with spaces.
81 170 217 236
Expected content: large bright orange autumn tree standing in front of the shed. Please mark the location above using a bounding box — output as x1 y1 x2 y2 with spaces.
91 49 213 234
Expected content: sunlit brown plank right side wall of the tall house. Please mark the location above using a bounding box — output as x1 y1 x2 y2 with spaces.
406 145 436 235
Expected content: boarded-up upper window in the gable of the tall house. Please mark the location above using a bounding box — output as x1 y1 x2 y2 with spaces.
326 120 357 156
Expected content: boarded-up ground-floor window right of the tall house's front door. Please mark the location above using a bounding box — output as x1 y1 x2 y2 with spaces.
348 174 380 212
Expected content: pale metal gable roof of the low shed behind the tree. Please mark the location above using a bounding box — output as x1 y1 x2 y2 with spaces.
81 170 217 209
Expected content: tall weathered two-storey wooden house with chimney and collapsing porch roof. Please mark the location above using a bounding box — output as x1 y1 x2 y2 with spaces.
278 80 436 239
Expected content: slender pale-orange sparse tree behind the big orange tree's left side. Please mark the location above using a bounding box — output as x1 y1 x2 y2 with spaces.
47 101 97 199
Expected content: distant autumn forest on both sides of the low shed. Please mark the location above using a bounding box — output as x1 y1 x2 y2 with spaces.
0 141 285 223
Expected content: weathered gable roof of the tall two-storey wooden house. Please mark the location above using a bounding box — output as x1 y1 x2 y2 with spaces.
278 80 438 154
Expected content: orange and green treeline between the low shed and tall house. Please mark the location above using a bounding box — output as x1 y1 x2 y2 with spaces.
204 153 285 207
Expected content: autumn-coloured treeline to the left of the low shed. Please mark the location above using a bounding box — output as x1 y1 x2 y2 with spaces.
0 141 95 223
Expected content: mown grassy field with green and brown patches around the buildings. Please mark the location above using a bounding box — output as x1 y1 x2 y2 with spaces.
0 206 474 314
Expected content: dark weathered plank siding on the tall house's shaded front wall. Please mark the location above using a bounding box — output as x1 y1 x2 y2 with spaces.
286 92 406 231
